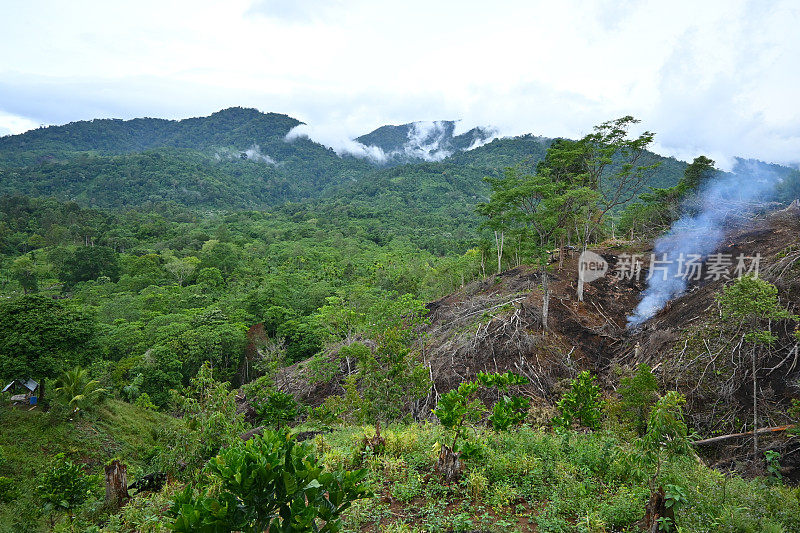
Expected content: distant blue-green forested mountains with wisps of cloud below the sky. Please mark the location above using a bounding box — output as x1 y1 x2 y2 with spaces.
0 108 685 210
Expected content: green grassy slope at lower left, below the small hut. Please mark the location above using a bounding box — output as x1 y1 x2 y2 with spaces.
0 399 179 533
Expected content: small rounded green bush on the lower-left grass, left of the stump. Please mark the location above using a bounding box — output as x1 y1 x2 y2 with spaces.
36 453 92 513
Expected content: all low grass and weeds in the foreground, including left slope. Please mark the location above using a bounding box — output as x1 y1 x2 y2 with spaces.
7 412 800 533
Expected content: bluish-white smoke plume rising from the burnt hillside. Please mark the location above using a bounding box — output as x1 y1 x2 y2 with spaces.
628 162 781 327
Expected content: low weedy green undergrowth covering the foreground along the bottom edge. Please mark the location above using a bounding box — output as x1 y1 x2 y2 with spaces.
100 424 800 533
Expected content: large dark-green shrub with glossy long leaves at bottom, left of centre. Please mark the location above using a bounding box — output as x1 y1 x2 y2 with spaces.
170 431 369 532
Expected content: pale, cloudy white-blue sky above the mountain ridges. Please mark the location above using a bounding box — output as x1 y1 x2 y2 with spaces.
0 0 800 167
